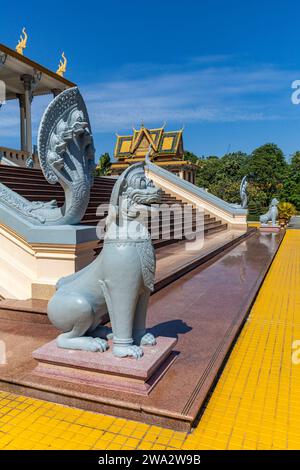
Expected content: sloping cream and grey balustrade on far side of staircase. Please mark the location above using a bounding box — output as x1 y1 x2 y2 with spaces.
147 162 247 229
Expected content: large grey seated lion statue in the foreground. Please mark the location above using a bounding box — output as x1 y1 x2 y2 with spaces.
48 162 161 358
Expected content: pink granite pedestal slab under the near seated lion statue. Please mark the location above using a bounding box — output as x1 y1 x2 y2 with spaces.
31 337 177 395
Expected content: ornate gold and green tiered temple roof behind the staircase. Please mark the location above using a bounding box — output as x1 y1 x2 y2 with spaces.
114 125 183 161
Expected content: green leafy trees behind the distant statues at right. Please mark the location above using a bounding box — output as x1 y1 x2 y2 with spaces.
186 143 300 213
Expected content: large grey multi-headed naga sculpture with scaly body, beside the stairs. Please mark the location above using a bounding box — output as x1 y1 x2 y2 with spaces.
0 87 95 225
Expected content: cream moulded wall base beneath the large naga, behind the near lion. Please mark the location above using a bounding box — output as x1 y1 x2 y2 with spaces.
0 224 98 300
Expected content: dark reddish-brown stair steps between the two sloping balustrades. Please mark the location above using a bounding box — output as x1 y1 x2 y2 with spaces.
0 165 227 252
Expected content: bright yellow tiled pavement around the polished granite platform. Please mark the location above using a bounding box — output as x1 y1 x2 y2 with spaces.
0 230 300 450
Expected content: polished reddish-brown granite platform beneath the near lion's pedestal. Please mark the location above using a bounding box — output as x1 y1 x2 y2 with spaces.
0 230 285 431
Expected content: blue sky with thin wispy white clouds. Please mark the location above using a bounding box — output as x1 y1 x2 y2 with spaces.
0 0 300 160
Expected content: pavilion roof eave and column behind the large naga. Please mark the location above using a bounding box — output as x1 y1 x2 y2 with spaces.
0 44 75 159
